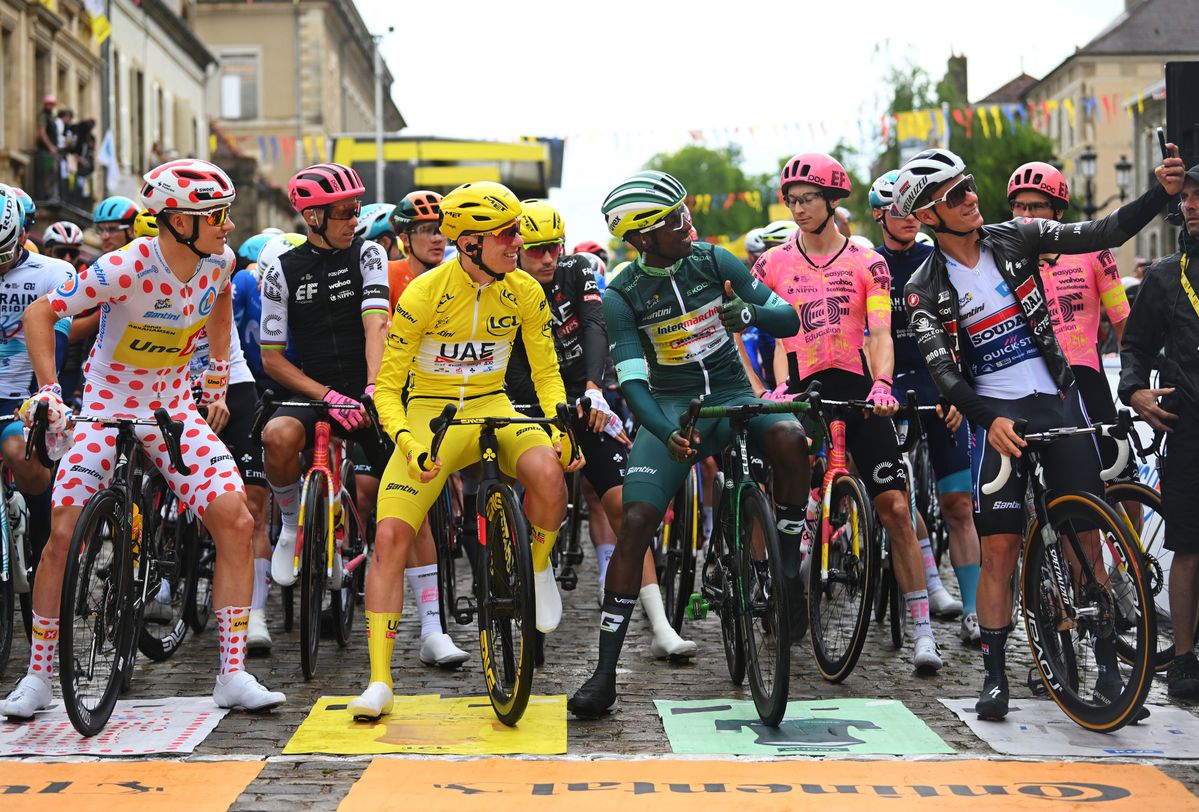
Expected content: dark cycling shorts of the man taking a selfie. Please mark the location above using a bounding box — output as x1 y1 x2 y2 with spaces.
970 386 1103 536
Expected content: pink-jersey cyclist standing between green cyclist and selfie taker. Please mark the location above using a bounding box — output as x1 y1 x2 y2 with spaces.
753 152 941 674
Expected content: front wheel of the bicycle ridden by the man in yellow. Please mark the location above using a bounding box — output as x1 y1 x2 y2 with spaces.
477 482 537 727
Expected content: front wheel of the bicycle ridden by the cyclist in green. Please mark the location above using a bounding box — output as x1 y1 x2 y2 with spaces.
737 485 791 727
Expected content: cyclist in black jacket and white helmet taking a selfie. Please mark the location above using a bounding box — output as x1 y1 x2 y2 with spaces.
894 149 1183 720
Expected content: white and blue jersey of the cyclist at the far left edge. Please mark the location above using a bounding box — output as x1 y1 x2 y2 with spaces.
0 251 76 399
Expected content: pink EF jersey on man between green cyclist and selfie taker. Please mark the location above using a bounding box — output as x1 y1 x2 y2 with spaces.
753 233 891 378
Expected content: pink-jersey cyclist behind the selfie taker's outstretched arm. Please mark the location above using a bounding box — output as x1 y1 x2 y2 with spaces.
1007 161 1128 465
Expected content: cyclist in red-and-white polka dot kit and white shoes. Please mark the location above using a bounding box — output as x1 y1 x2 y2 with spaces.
0 160 284 720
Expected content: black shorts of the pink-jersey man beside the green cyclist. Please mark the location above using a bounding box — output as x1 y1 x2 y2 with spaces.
796 369 908 499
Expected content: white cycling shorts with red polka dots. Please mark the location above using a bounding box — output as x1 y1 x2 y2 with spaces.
52 397 245 519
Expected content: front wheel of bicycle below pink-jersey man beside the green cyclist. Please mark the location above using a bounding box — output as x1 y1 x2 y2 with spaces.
808 476 879 682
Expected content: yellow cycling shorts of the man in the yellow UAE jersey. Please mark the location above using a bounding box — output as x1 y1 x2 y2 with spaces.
375 392 556 530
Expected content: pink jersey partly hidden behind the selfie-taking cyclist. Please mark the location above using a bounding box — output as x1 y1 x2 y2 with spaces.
1041 251 1128 372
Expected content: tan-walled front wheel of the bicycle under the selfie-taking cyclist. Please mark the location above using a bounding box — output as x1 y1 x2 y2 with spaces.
1022 493 1156 733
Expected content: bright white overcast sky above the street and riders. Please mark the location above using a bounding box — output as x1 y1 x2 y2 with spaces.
355 0 1125 246
